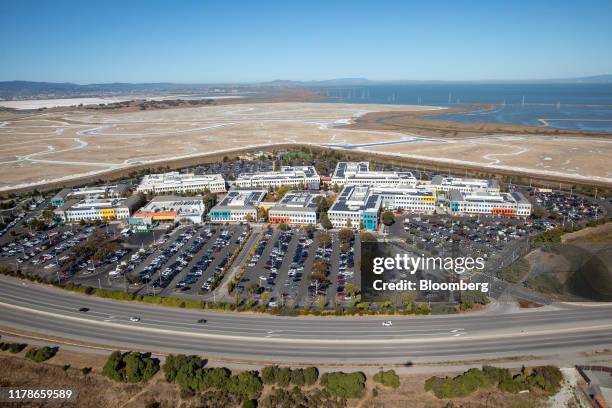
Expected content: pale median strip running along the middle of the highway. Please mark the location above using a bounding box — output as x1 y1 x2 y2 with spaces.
0 302 612 344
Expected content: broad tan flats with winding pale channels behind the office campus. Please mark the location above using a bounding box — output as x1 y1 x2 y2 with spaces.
0 102 612 191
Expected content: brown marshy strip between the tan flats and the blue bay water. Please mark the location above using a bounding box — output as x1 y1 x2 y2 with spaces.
343 105 612 138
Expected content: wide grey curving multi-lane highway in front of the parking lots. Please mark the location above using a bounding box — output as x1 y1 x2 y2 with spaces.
0 276 612 364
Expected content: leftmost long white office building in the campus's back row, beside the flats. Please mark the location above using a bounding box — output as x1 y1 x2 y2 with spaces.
136 171 226 194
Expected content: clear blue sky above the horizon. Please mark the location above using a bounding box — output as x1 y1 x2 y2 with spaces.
0 0 612 83
